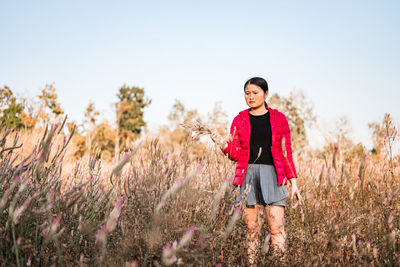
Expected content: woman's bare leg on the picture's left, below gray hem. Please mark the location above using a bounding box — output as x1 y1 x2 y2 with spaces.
244 205 261 264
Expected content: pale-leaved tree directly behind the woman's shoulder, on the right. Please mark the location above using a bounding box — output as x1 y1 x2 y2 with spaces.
269 90 316 153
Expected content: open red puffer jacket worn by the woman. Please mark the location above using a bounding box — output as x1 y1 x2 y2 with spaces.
222 107 297 185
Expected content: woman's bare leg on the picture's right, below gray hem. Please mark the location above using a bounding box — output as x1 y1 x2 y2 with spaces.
265 206 286 254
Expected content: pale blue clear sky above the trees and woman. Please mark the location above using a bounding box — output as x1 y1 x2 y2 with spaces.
0 0 400 149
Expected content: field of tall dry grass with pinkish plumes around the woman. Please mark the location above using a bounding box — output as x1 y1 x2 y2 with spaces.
0 126 400 266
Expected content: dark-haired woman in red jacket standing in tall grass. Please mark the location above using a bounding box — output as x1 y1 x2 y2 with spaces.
211 77 302 263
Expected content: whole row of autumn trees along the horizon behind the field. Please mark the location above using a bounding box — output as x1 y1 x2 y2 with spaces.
0 84 397 163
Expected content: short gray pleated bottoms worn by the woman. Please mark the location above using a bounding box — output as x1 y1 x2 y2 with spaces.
235 164 289 207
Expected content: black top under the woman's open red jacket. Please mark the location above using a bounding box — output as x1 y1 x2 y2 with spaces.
249 112 274 165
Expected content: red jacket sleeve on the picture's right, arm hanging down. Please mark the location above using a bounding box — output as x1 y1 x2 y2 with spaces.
282 114 297 179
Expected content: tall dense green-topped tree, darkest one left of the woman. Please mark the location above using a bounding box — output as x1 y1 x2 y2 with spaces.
116 85 151 152
